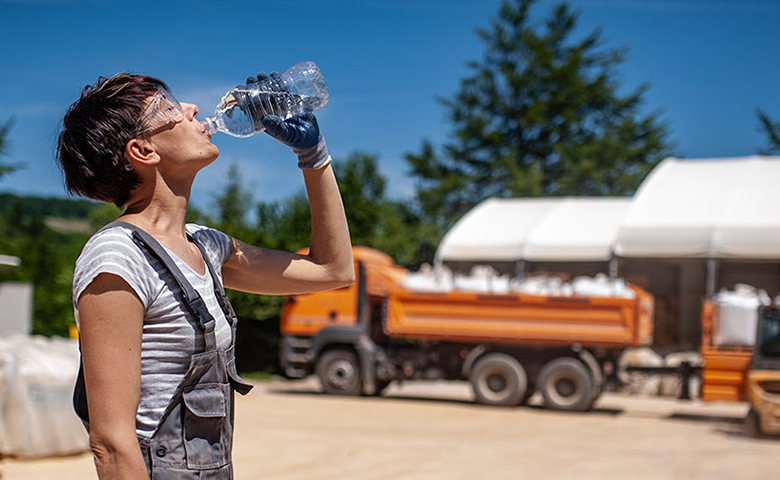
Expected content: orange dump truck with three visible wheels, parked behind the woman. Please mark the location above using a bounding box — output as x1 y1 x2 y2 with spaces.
281 247 653 411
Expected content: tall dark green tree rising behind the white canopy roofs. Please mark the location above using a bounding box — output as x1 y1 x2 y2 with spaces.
406 0 671 229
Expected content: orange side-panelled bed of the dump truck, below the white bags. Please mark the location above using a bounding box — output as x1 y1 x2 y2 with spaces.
384 286 653 348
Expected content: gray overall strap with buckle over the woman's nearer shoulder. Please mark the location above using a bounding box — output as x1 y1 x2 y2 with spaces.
104 220 217 351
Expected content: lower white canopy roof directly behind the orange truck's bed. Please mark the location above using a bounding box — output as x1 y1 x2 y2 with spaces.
436 197 631 263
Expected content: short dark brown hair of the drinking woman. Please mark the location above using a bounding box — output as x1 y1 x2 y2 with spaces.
57 73 168 208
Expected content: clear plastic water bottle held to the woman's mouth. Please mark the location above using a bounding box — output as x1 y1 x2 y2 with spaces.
201 62 328 137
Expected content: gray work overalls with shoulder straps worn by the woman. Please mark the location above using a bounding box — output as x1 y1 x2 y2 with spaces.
74 222 252 480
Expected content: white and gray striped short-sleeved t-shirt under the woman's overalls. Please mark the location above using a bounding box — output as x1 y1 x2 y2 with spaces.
73 224 232 438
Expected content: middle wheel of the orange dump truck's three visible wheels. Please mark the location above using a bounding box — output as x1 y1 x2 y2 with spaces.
469 353 528 407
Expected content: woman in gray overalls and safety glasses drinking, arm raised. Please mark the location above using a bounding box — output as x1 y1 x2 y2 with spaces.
58 74 354 479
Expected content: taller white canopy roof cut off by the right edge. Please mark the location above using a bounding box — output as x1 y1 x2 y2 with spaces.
614 156 780 260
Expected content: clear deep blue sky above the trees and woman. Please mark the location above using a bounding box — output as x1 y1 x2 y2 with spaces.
0 0 780 212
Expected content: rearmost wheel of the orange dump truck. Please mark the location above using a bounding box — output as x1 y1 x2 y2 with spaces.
539 357 593 412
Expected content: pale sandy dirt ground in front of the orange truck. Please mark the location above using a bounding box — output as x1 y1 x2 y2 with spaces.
0 381 780 480
